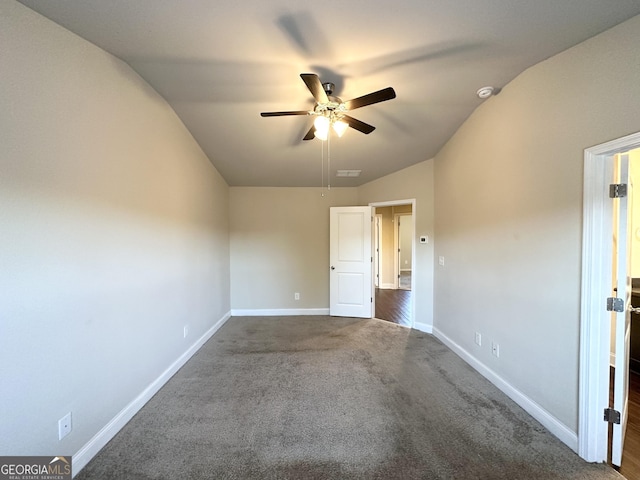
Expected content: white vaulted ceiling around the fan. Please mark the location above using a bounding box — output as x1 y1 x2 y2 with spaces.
20 0 640 186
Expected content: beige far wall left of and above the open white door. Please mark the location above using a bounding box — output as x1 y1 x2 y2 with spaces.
230 187 357 313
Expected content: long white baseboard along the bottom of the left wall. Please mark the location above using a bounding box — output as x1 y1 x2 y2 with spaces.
72 312 231 477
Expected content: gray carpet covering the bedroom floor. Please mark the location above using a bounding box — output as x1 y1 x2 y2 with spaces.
76 317 622 480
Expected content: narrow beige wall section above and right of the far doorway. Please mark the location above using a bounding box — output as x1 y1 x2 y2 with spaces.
358 160 434 330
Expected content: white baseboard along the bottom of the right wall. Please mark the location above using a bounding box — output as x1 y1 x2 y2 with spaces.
433 327 578 453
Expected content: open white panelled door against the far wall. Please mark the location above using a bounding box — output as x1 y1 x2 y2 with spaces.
329 207 373 318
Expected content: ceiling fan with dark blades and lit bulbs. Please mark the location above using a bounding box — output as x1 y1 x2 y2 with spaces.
260 73 396 140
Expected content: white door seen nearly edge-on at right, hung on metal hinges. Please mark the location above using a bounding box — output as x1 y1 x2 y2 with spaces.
611 154 633 466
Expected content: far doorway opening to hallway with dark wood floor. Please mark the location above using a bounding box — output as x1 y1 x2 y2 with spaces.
370 200 417 327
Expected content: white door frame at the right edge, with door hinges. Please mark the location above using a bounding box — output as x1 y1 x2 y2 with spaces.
578 132 640 462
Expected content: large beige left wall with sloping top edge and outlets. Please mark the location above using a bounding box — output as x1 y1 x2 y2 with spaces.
0 0 230 463
